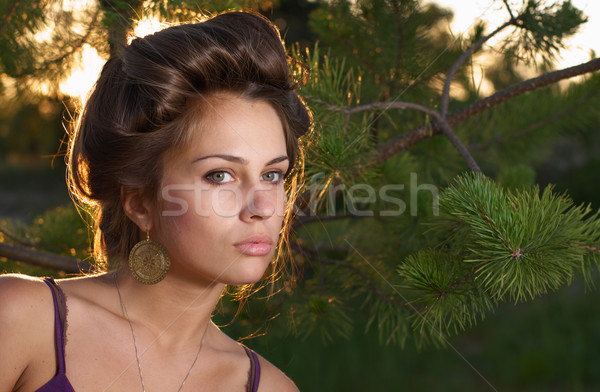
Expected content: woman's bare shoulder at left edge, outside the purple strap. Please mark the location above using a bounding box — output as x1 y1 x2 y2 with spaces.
0 274 54 390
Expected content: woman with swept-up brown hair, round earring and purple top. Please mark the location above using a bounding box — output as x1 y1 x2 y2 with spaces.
0 12 310 392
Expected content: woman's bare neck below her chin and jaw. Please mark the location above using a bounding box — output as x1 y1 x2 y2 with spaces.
116 269 225 347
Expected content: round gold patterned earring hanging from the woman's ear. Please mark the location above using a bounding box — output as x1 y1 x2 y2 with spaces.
129 231 171 284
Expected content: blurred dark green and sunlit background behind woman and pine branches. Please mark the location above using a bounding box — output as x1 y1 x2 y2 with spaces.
0 0 600 391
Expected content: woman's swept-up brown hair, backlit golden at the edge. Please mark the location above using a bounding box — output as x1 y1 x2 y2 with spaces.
68 12 310 266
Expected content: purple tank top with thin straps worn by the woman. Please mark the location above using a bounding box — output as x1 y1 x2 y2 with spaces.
37 278 260 392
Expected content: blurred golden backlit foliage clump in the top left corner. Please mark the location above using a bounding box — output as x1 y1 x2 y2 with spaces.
0 0 106 94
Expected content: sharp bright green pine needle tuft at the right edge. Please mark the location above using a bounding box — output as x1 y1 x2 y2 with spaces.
440 174 600 301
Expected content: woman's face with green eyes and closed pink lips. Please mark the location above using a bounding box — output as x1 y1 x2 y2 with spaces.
151 93 289 285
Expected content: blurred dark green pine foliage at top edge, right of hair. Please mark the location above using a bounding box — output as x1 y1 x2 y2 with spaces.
309 0 457 101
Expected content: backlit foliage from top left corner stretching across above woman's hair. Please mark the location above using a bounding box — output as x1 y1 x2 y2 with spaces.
0 0 292 98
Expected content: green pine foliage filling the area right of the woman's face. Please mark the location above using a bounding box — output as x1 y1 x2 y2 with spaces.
282 1 600 346
